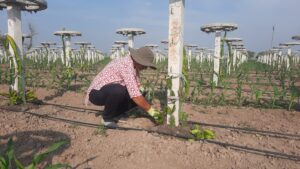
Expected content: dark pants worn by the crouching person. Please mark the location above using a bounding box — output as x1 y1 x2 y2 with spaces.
89 84 137 120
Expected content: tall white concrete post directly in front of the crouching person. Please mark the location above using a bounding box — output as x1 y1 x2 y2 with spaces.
167 0 185 126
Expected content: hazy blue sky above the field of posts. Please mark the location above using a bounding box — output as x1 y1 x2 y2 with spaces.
0 0 300 52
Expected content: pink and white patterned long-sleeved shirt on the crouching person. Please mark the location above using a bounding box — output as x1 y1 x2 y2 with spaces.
85 56 142 105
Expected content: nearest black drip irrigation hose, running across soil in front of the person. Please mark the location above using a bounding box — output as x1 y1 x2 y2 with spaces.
1 107 300 161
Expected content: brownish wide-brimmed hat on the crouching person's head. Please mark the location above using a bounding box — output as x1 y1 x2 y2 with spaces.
129 46 156 69
